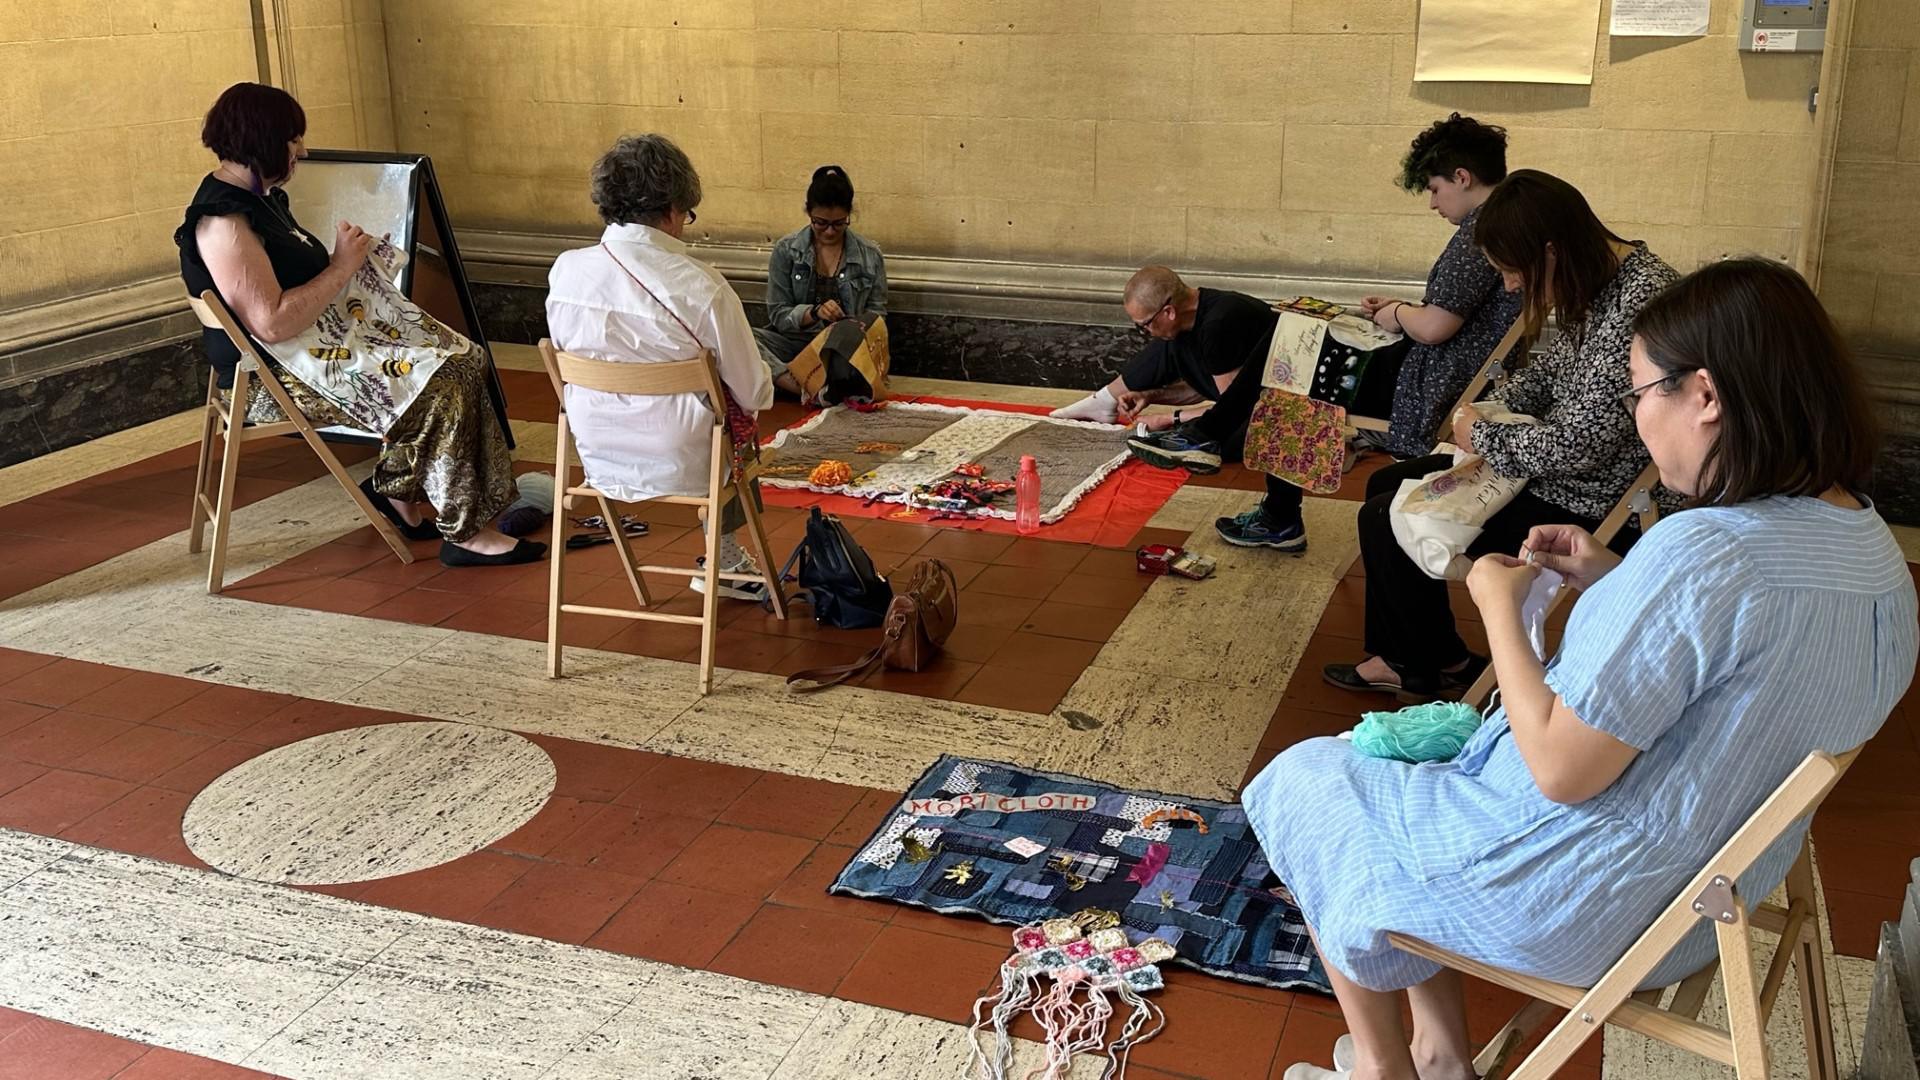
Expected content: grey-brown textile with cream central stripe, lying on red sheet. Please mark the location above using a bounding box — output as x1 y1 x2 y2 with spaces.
760 402 1129 525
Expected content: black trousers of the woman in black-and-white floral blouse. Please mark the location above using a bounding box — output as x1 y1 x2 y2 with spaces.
1359 454 1624 680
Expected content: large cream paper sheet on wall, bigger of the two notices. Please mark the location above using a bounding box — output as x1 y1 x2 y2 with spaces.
1413 0 1599 86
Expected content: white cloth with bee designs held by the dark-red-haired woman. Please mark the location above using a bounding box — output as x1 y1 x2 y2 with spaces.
259 240 458 434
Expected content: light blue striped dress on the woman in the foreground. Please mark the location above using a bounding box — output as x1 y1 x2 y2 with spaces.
1242 498 1920 990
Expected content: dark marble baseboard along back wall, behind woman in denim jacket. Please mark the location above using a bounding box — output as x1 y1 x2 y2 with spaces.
474 284 1144 390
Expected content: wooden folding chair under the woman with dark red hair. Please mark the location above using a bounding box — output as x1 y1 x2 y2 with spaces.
186 288 413 594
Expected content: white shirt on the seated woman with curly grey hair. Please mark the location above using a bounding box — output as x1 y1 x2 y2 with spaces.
547 225 774 502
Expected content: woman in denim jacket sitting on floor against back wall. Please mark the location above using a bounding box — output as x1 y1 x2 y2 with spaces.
755 165 887 398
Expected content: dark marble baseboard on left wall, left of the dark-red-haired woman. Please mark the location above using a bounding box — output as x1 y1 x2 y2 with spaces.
0 334 207 467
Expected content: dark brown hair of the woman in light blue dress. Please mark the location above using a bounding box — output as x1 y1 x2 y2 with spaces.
1634 258 1880 505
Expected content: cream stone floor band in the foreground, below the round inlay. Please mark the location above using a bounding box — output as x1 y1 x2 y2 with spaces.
0 830 1067 1080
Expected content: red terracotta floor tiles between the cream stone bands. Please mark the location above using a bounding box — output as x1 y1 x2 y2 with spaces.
0 428 1920 1080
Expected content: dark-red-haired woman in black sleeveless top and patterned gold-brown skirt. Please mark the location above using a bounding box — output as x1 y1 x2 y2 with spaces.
173 83 547 567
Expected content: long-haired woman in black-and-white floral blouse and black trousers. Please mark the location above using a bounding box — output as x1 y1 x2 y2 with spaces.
1325 169 1676 700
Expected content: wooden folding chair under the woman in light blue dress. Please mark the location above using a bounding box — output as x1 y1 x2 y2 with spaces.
1386 748 1860 1080
